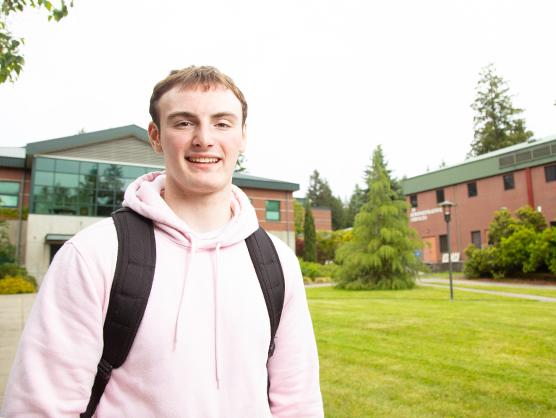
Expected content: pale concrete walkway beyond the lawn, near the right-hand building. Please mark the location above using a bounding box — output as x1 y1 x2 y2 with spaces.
417 278 556 303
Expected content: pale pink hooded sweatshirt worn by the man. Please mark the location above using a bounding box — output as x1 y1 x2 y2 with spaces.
3 173 323 418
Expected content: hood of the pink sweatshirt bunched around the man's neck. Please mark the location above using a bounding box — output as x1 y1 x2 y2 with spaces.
123 172 259 249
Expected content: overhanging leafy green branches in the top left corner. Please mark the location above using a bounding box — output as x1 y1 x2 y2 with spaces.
0 0 73 84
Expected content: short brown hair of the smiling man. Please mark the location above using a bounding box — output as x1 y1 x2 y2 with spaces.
149 65 247 129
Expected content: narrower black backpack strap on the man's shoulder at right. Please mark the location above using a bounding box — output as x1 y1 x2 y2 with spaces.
245 227 285 357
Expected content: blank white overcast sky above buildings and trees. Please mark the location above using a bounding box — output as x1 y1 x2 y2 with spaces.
0 0 556 198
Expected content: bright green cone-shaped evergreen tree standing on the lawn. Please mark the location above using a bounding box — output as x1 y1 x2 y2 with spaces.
336 146 421 289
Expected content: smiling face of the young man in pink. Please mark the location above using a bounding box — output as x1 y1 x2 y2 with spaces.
149 86 246 199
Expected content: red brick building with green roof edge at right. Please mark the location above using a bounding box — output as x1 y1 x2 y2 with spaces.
403 136 556 265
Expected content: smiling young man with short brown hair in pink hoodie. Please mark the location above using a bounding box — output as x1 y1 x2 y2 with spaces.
3 67 323 418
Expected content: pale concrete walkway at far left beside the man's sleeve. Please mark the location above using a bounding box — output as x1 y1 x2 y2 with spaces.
0 293 35 405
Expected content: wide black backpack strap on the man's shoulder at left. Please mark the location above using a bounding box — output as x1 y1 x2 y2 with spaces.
81 208 156 418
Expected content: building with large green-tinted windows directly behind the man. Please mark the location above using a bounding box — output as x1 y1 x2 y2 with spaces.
0 125 299 282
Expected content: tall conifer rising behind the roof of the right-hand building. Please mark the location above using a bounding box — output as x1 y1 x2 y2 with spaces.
468 64 533 157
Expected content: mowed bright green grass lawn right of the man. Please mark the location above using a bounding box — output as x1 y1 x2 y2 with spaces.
307 287 556 418
